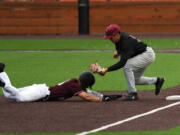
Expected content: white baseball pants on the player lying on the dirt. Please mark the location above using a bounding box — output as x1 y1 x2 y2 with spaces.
0 72 50 102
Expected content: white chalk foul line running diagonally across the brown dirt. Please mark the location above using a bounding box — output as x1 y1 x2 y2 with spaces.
76 102 180 135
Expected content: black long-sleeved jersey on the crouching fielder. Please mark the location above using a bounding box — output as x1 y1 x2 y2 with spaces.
108 32 147 71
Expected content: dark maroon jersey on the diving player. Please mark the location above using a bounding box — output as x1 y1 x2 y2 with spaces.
49 78 82 100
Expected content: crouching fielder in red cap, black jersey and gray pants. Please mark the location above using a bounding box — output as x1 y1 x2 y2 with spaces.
90 24 164 101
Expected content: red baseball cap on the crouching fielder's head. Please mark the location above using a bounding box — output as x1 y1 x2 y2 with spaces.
104 24 120 39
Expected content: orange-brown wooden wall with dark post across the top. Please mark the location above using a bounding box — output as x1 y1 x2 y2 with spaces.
0 0 180 35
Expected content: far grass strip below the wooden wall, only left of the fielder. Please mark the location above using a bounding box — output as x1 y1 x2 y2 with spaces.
0 39 114 50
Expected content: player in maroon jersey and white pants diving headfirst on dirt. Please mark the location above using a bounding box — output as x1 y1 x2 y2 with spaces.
0 63 121 102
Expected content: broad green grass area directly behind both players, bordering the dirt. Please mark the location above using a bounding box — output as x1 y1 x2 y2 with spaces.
0 52 180 94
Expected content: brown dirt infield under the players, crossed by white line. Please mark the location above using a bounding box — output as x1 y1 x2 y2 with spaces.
0 86 180 133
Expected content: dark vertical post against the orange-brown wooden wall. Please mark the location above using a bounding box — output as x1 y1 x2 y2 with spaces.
78 0 89 35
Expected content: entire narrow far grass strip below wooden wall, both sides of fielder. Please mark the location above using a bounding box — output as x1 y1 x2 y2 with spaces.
0 39 180 50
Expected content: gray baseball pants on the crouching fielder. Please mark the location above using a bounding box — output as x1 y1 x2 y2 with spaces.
123 47 157 93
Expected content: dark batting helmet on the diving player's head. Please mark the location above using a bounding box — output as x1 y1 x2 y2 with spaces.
79 71 95 89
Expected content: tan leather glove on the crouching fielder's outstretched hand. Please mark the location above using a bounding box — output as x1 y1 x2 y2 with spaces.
90 62 107 76
